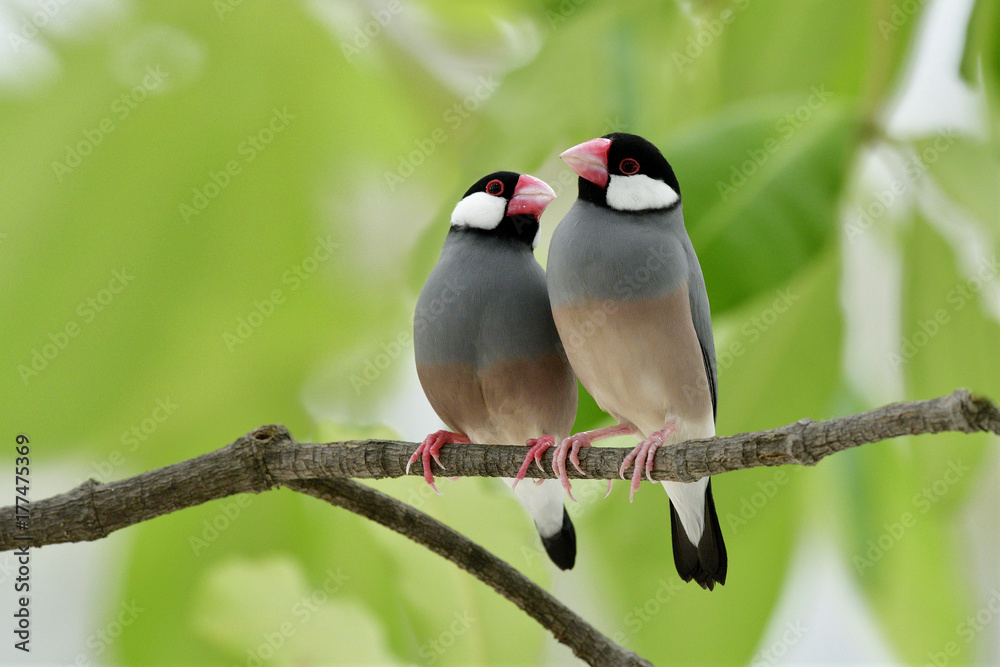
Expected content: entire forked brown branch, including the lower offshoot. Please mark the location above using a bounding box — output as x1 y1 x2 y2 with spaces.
0 389 1000 664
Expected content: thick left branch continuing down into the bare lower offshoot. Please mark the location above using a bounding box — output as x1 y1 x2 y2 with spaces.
0 426 652 667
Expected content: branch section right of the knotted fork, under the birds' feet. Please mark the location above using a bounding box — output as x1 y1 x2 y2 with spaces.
266 389 1000 482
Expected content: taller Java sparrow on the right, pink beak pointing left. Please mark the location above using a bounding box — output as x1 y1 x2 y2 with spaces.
547 133 727 590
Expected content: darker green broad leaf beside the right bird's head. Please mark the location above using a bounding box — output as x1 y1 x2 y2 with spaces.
669 99 858 313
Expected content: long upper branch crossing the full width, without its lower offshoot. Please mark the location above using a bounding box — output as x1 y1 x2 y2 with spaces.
0 389 1000 551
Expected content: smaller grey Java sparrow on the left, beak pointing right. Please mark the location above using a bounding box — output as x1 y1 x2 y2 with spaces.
407 171 577 570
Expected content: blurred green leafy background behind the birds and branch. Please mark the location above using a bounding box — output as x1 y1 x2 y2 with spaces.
0 0 1000 665
